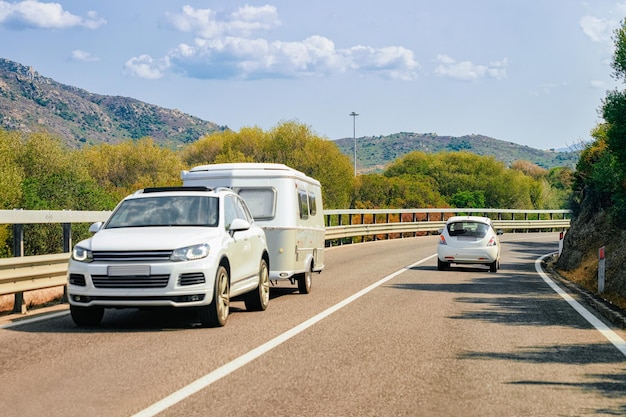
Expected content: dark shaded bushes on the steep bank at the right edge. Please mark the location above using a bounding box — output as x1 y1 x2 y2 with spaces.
555 17 626 308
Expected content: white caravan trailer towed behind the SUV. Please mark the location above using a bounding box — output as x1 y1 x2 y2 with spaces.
181 163 325 294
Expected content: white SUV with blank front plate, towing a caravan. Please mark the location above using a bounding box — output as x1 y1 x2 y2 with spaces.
67 187 270 326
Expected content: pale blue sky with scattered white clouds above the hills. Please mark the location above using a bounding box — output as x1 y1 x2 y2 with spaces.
0 0 626 149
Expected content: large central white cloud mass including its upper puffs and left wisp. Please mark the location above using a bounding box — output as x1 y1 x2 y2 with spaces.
134 5 419 80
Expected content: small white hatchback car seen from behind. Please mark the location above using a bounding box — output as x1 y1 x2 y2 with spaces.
437 216 502 272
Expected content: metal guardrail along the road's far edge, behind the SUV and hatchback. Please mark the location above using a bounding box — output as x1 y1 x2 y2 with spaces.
0 208 570 313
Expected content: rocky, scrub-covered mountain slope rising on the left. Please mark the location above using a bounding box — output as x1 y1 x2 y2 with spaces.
0 58 226 148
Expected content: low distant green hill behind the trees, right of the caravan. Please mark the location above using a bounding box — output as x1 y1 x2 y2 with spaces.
335 132 579 172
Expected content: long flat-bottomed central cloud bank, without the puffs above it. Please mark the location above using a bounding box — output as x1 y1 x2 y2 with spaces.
160 35 419 80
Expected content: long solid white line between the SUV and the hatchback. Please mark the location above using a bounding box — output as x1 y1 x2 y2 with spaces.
133 254 437 417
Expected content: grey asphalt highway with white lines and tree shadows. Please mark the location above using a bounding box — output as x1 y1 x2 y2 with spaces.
0 233 626 417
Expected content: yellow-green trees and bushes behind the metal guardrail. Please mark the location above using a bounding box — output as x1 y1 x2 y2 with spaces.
0 118 573 257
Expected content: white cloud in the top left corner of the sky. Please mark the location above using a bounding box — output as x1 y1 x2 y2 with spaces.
0 0 106 29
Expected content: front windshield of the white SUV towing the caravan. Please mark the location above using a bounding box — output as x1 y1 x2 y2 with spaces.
105 196 218 229
